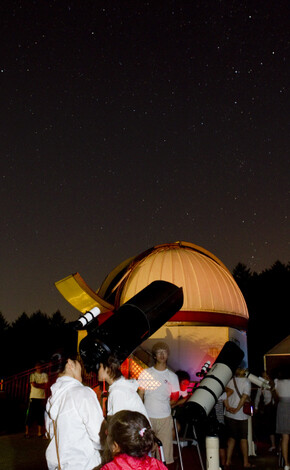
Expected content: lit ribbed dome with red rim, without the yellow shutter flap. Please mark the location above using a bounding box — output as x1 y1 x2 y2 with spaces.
115 242 248 326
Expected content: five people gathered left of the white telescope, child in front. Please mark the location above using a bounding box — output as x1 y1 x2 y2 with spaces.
25 342 180 470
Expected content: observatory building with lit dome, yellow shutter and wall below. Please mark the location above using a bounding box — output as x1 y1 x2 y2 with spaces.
56 242 249 380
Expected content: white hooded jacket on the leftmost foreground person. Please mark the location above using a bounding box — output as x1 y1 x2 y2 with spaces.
45 376 103 470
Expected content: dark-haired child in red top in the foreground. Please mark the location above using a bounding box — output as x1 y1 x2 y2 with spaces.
97 410 167 470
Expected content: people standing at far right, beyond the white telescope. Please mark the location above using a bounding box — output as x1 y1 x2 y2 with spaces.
215 368 290 470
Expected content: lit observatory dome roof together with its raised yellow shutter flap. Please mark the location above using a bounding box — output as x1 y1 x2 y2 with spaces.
55 242 249 329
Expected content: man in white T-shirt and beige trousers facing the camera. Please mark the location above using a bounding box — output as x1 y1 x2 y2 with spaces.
138 341 180 465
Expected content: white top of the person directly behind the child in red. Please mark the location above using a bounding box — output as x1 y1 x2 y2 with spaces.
107 377 150 422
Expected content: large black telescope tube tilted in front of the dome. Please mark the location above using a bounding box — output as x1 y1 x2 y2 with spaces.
79 281 183 371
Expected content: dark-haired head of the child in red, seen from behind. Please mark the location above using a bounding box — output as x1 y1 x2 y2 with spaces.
107 410 155 458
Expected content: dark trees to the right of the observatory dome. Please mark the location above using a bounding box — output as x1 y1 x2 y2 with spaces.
233 261 290 374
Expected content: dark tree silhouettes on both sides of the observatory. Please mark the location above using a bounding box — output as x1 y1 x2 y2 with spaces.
0 261 290 378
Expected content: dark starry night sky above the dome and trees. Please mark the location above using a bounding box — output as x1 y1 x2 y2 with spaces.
0 0 290 321
